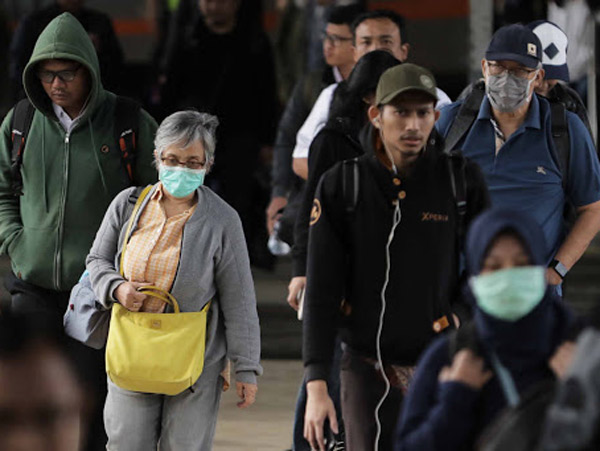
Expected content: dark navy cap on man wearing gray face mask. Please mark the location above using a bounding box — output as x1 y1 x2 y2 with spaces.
485 24 542 68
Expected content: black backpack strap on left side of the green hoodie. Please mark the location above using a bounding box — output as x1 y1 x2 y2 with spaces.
10 98 35 196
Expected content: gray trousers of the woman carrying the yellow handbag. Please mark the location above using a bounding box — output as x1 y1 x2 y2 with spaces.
104 362 223 451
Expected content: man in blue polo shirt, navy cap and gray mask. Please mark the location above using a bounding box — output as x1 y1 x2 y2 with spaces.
436 25 600 293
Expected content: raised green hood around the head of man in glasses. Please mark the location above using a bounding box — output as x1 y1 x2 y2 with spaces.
23 13 104 115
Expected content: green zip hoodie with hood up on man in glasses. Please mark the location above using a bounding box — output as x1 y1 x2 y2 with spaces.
0 13 157 291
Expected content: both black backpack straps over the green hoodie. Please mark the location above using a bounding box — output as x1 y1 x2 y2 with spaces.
10 96 140 197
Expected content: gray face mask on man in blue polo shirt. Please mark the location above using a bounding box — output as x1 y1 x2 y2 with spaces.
485 71 537 113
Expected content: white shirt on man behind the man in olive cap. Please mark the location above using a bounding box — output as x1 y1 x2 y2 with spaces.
292 83 452 158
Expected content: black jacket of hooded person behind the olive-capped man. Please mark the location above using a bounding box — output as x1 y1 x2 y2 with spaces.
292 117 371 277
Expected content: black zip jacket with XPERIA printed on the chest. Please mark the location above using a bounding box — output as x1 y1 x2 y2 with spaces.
303 135 489 381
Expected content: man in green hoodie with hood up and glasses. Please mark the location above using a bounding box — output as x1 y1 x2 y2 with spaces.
0 13 156 449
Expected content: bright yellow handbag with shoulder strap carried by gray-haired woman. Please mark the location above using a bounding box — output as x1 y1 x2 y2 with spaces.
106 186 210 395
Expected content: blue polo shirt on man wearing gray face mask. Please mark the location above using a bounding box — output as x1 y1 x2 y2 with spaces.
436 95 600 261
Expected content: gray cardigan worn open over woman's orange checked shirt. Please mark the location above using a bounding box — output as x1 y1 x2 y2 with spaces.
86 185 262 383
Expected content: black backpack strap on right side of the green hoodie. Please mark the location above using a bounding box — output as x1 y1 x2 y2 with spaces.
114 96 140 183
